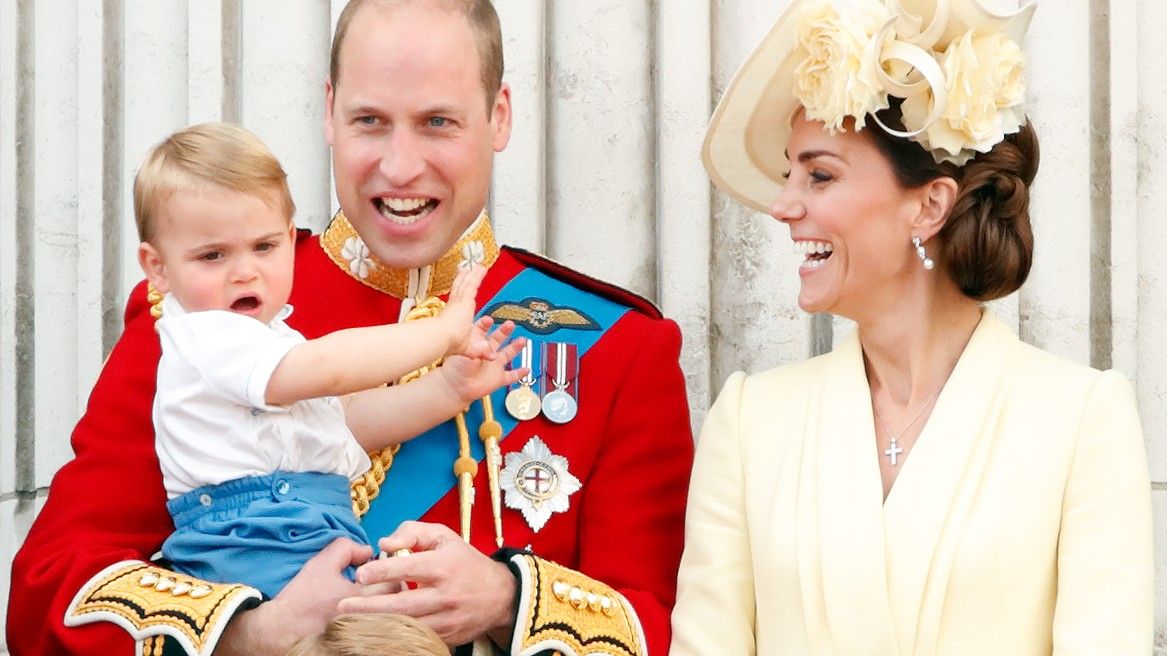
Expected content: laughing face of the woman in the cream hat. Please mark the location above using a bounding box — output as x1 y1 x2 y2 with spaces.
770 112 925 319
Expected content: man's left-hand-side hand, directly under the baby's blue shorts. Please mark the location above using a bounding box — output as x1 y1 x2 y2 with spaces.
215 538 372 656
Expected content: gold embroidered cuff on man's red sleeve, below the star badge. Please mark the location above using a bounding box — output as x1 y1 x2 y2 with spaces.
511 554 648 656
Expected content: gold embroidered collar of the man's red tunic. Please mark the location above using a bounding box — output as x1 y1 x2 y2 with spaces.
320 210 498 299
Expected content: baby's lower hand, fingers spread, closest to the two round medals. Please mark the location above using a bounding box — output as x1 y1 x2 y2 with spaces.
439 316 529 405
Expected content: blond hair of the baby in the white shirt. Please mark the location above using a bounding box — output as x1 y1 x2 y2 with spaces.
134 123 295 242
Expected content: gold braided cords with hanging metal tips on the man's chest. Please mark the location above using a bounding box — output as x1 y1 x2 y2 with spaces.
350 296 503 546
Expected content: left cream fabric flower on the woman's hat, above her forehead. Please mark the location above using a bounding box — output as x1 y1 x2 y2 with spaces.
795 0 890 131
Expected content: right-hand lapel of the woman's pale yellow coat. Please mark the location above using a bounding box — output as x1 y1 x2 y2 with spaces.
885 310 1019 655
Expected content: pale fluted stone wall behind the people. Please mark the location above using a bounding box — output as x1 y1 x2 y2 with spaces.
0 0 1167 652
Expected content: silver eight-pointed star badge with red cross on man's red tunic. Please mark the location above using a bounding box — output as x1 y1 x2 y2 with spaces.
499 435 582 532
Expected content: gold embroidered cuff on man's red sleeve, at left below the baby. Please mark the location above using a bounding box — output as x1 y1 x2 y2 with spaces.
64 560 261 656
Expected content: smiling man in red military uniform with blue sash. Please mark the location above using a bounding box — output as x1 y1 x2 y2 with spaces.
8 0 692 656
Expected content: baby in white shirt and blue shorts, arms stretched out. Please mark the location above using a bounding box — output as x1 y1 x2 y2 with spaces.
134 124 523 598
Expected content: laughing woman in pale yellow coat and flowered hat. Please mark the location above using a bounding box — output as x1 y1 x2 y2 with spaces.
672 0 1154 656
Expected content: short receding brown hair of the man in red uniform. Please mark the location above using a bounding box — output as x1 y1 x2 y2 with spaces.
328 0 503 113
